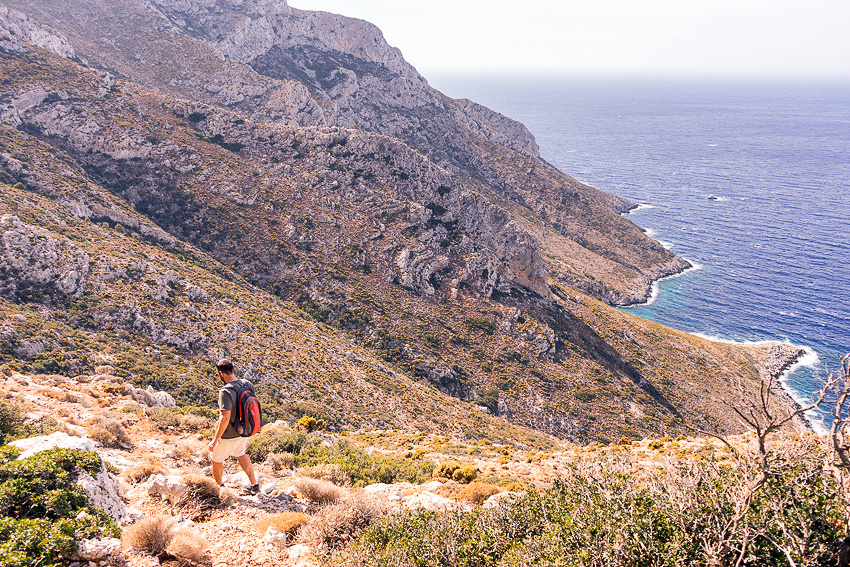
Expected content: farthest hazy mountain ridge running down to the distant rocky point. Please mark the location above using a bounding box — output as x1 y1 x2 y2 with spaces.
0 0 688 304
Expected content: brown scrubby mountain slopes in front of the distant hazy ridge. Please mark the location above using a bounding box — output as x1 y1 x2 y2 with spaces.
0 38 796 439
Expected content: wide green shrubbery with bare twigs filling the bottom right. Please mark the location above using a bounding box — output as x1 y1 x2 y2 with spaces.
341 450 850 567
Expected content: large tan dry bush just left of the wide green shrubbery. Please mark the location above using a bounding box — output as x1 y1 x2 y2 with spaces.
298 494 390 552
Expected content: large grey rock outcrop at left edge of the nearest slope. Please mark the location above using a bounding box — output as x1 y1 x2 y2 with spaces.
0 215 90 297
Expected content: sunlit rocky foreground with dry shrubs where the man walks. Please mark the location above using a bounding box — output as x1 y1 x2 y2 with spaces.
0 364 850 567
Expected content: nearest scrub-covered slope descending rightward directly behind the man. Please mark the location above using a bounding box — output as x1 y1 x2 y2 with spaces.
0 131 546 445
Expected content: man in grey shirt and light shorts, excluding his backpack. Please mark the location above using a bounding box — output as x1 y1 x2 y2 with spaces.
209 358 260 494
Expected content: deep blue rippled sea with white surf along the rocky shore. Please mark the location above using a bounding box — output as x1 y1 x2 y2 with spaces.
429 74 850 424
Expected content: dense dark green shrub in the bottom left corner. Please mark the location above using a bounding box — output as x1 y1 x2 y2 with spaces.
0 447 119 567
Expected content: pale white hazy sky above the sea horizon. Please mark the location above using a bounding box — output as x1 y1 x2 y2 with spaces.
289 0 850 78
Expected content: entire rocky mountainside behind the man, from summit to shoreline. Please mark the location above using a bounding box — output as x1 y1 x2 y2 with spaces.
0 0 798 446
